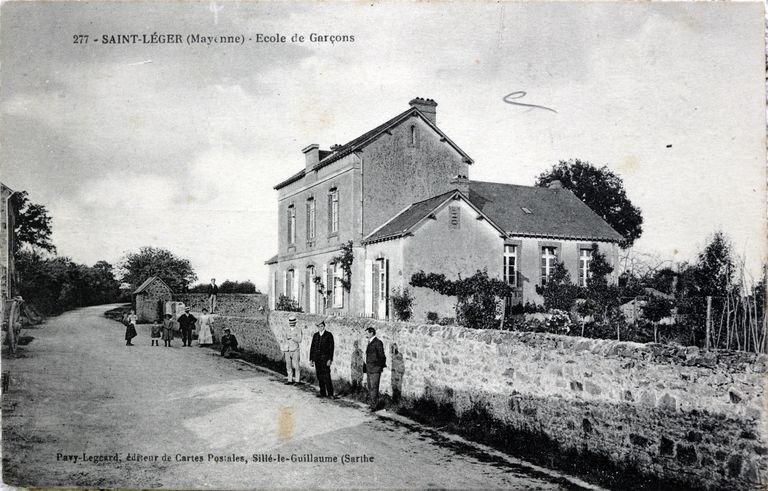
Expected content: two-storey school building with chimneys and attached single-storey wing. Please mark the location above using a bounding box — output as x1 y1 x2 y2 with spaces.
266 98 622 320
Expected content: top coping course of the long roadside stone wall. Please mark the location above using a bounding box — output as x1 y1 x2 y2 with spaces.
269 311 768 373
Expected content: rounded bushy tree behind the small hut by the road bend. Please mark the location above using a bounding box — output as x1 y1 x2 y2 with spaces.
120 247 197 292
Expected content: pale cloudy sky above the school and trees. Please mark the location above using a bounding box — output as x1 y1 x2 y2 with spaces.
0 2 766 288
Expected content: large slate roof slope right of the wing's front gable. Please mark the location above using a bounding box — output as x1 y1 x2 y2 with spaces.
469 181 623 242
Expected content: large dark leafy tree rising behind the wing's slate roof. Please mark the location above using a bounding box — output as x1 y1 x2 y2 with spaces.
536 159 643 249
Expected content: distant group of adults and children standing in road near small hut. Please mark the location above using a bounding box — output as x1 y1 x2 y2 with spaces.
123 307 213 347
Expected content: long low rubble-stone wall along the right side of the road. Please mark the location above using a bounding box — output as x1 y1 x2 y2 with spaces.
260 312 768 489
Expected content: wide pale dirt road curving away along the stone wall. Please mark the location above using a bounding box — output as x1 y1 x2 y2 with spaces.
2 306 592 489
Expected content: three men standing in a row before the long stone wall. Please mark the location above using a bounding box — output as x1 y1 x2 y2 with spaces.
280 315 387 411
